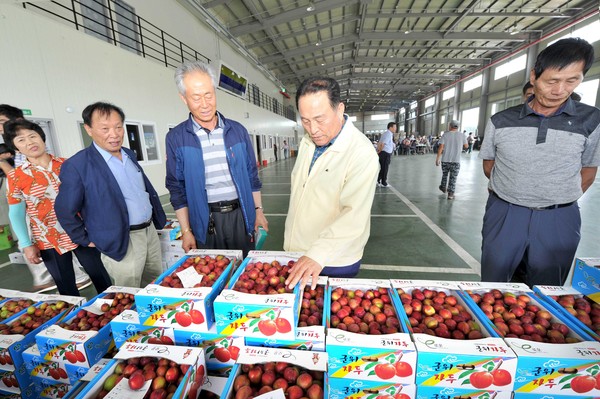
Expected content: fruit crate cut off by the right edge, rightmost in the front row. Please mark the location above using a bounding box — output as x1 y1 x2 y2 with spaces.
533 285 600 341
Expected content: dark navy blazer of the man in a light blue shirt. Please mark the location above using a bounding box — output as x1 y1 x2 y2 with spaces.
54 144 167 261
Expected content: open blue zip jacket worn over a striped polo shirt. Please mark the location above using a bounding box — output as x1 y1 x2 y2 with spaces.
166 114 262 244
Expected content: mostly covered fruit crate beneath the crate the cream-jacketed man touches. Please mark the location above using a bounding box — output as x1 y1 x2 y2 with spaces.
246 276 327 352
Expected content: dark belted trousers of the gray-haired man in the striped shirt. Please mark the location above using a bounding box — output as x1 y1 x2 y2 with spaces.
196 208 255 257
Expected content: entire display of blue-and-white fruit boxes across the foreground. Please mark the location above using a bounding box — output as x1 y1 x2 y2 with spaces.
0 255 600 399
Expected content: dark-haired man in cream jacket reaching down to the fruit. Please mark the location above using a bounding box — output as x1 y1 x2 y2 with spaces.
283 77 379 288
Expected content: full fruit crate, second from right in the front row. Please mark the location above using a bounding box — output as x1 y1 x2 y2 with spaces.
461 283 600 397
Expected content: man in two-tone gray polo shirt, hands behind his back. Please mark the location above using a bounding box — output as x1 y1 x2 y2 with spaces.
479 38 600 286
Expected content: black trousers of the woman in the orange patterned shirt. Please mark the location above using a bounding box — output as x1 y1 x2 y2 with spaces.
40 246 112 296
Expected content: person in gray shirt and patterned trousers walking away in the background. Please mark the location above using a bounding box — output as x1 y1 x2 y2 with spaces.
435 120 467 199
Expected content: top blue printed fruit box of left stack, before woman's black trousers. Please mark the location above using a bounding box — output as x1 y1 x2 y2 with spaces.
35 286 139 368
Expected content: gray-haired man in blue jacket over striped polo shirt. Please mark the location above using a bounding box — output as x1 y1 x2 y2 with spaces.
166 61 268 255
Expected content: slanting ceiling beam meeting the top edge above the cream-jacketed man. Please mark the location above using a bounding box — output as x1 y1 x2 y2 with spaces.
229 0 359 36
